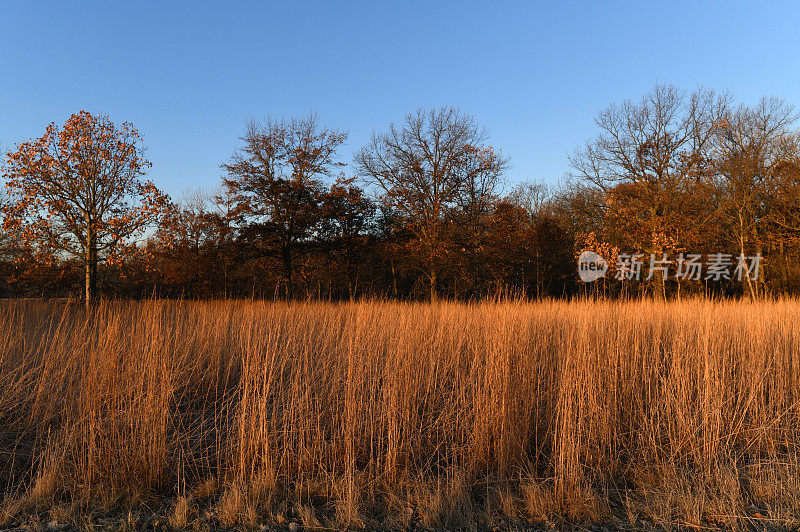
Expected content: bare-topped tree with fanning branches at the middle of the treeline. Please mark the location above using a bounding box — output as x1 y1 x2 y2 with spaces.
356 107 505 301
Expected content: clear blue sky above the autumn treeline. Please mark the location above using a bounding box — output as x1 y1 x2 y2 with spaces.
0 0 800 196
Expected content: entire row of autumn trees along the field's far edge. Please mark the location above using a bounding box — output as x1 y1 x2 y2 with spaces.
0 82 800 301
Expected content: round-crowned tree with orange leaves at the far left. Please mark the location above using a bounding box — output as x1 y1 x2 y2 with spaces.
3 111 169 307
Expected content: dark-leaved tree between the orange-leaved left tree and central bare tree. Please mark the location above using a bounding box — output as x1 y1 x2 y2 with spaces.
222 114 347 298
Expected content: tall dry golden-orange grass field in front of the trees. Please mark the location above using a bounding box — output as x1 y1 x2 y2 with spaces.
0 300 800 529
